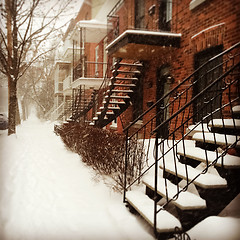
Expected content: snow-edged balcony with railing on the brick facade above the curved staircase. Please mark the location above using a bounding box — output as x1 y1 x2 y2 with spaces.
106 0 181 60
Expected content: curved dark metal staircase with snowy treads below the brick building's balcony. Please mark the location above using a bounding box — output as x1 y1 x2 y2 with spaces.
93 59 143 128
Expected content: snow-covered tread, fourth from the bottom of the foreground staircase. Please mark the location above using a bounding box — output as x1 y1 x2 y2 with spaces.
177 147 240 168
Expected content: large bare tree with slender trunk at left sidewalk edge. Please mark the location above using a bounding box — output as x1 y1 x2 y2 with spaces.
0 0 70 135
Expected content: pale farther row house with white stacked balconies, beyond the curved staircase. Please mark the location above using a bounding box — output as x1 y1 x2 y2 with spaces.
51 0 117 121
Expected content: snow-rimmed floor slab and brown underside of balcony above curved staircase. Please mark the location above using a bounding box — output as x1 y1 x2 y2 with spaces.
106 30 181 60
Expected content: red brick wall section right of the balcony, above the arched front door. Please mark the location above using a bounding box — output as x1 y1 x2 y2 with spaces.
172 0 240 81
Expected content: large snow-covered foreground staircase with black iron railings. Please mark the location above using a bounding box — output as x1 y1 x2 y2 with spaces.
123 43 240 239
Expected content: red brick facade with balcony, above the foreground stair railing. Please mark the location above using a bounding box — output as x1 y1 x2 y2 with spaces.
102 0 240 135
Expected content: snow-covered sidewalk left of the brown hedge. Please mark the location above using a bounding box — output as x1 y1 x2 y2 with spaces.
0 117 154 240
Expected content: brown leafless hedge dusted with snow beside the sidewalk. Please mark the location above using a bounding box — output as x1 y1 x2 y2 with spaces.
55 123 143 191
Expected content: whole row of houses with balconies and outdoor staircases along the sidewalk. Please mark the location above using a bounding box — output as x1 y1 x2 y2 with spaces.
54 0 240 239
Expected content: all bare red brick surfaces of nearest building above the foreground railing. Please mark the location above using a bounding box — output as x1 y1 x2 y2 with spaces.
112 0 240 137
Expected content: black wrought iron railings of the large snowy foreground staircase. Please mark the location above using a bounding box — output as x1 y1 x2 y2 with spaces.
124 43 240 234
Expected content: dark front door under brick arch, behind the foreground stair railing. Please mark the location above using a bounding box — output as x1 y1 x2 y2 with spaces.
193 46 223 123
